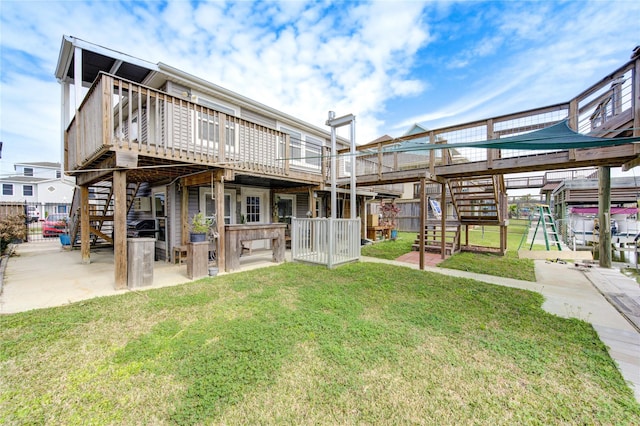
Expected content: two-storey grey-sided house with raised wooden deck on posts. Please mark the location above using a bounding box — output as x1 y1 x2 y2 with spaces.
55 36 398 287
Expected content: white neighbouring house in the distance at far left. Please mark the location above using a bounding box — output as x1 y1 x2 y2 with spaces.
0 162 74 219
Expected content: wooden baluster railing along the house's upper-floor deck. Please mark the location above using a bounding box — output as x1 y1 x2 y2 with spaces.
65 74 312 181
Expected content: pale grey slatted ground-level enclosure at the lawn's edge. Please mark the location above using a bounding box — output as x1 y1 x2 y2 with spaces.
291 218 361 268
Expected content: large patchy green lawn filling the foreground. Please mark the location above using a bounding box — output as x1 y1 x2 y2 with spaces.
0 262 640 425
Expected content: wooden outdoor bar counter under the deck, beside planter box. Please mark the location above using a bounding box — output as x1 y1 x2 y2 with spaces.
224 223 287 272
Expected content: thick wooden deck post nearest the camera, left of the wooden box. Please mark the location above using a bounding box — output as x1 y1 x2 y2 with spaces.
113 170 127 289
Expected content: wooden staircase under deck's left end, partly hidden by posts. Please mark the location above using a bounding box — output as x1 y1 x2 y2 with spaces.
69 181 140 247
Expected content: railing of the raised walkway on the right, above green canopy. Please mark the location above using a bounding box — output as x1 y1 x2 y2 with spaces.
339 58 640 177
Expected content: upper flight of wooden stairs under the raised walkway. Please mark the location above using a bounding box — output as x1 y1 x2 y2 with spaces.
448 175 506 226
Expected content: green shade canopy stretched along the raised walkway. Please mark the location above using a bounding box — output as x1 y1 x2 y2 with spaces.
385 120 640 152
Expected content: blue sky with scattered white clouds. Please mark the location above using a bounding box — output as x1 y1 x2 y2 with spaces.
0 0 640 183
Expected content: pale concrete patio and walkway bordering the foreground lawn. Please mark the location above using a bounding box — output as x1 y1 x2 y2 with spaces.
0 241 640 402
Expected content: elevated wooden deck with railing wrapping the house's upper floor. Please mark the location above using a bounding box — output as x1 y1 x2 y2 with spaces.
65 74 326 185
